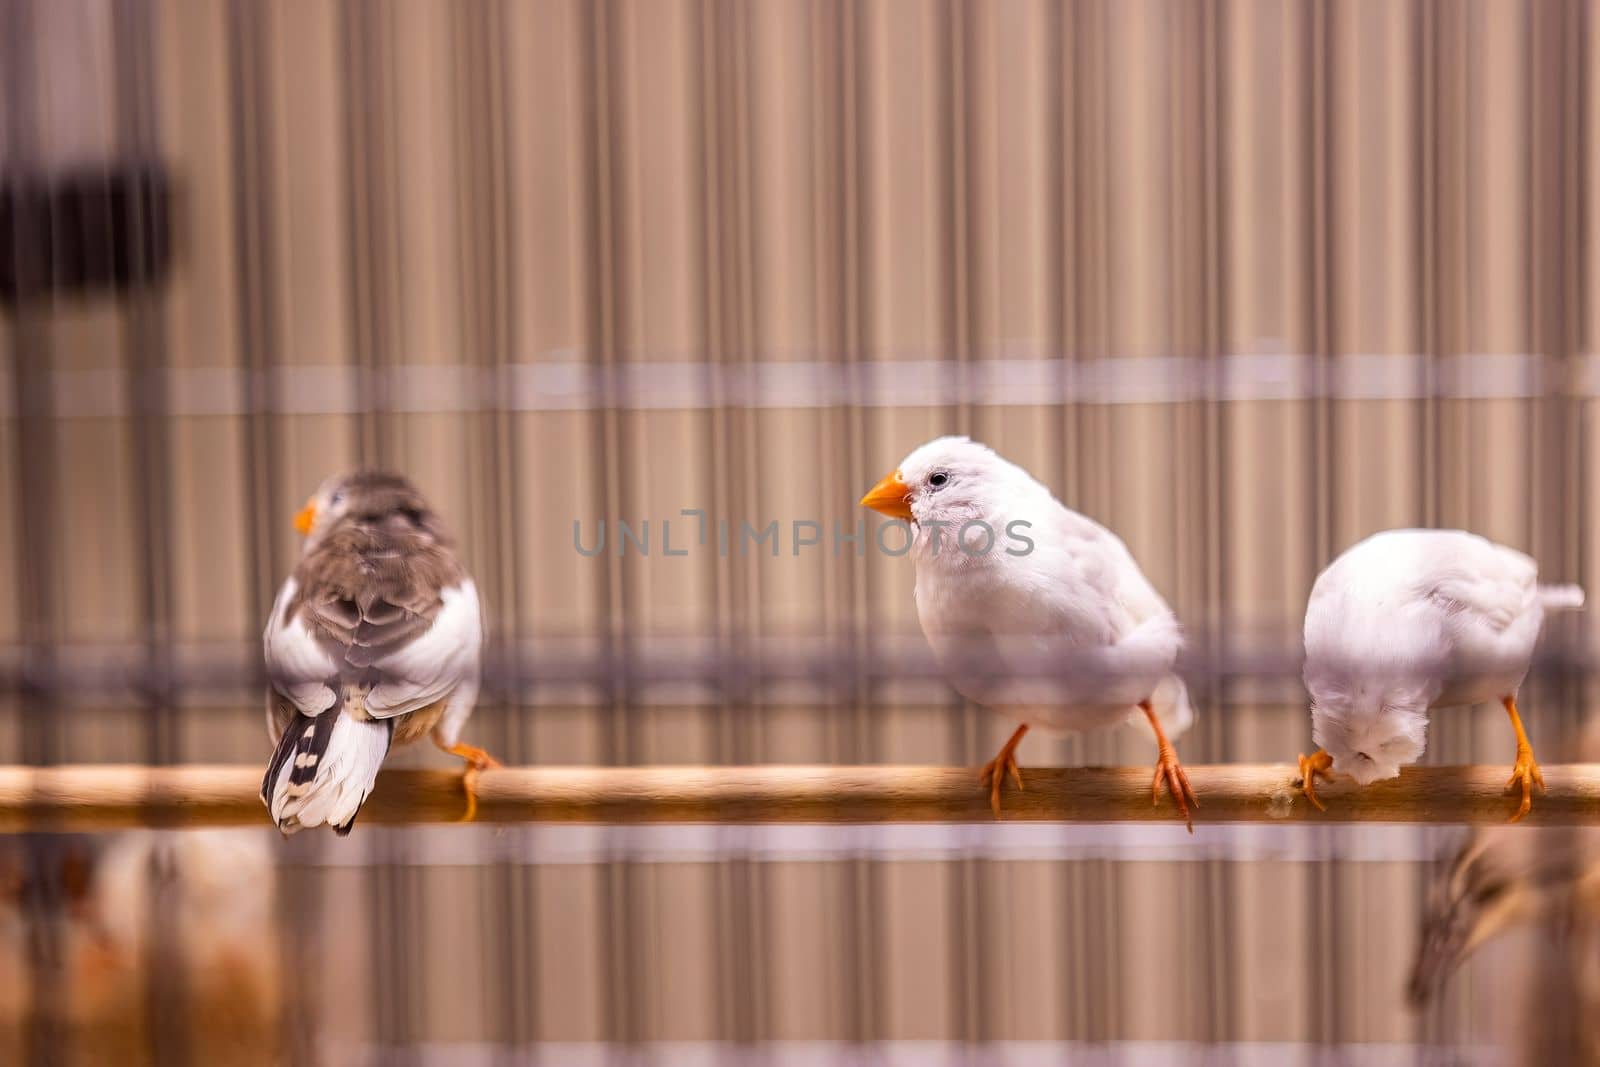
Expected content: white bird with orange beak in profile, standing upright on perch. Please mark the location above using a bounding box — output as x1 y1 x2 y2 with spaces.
861 437 1200 833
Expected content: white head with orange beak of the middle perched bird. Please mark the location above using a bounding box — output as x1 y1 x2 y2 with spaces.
861 437 1048 537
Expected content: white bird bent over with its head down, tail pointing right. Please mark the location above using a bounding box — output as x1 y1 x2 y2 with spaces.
1299 530 1584 822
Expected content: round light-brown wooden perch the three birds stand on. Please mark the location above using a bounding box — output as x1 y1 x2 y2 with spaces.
0 763 1600 833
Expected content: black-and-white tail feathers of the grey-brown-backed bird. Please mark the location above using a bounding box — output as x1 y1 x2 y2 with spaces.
261 710 394 835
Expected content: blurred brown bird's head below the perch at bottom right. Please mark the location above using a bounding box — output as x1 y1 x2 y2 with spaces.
1406 832 1539 1008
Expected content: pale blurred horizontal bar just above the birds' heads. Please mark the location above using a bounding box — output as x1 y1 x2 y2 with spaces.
0 350 1580 419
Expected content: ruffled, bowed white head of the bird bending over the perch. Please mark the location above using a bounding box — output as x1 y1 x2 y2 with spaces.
1310 686 1427 785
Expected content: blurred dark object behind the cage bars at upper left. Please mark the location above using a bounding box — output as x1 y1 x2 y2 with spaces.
0 163 173 304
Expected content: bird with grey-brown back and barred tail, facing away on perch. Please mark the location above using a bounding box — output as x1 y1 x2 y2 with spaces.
261 470 499 837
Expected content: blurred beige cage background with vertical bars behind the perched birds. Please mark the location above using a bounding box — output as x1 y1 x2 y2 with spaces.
0 0 1600 1064
